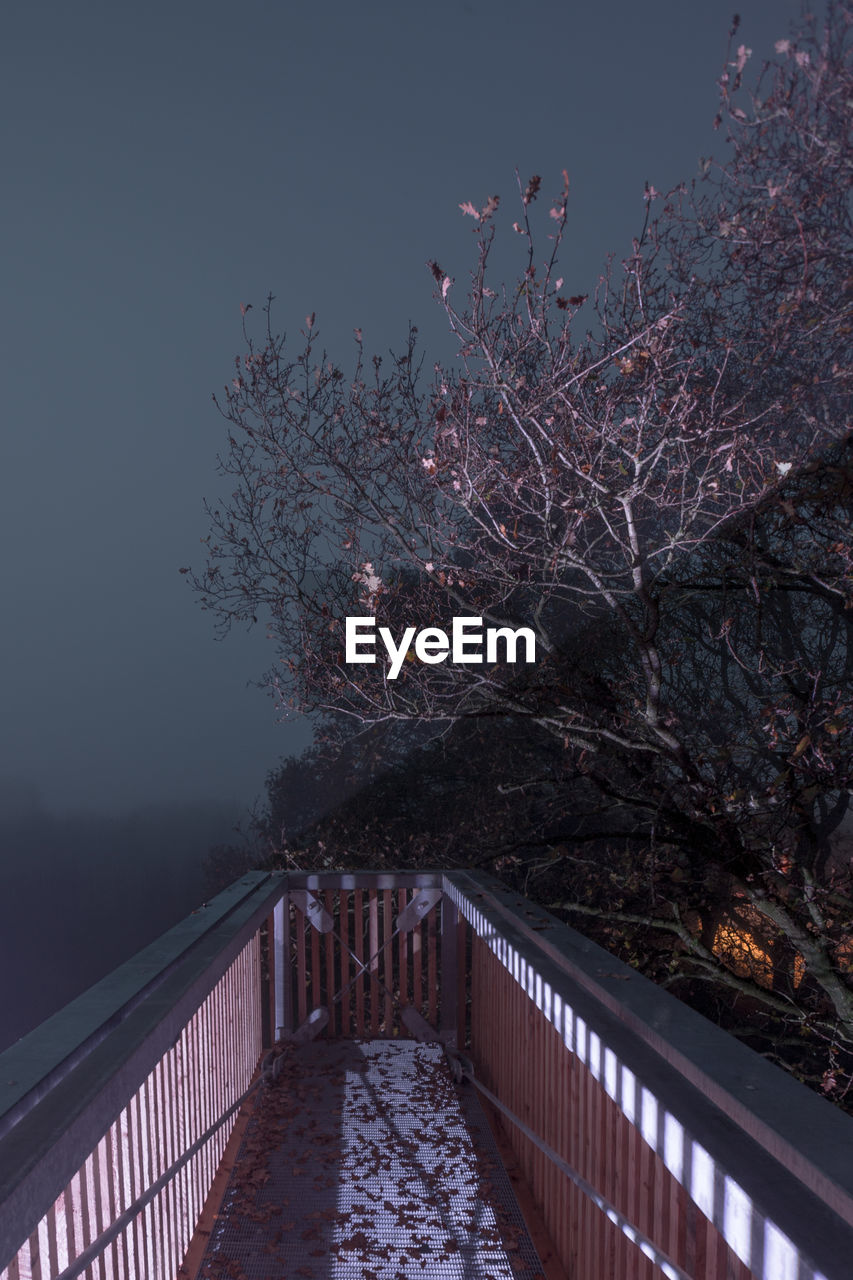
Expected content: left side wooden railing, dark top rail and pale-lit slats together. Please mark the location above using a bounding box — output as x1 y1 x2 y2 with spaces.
0 876 280 1280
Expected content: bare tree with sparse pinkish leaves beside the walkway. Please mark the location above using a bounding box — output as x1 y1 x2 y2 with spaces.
192 4 853 1090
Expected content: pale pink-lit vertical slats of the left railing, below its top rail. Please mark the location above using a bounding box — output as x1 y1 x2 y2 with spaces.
0 933 261 1280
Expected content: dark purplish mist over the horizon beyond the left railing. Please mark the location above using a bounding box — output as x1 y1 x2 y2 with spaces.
0 786 245 1052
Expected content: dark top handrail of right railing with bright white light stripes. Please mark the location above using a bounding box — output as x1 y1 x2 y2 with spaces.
444 870 853 1280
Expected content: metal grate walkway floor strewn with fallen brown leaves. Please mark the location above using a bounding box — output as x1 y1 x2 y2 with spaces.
199 1041 543 1280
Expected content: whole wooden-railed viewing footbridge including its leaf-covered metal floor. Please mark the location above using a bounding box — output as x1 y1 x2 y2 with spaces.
0 870 853 1280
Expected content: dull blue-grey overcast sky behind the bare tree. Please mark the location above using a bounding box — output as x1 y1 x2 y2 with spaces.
0 0 799 814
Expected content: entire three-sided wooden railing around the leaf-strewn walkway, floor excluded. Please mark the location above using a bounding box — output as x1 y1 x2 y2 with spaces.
0 872 853 1280
